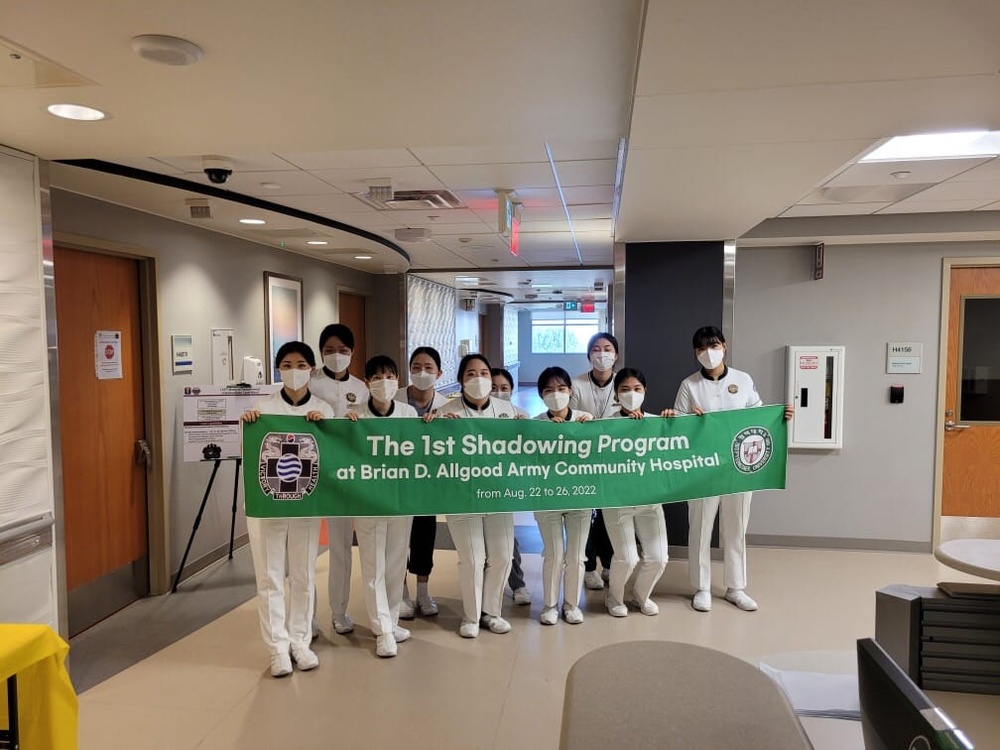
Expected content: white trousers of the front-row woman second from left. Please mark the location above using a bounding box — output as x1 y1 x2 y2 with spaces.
354 516 413 635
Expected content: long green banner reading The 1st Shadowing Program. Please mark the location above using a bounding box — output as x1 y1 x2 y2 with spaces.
243 406 787 518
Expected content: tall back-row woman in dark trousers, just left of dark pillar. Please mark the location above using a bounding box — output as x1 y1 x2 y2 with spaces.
569 331 618 591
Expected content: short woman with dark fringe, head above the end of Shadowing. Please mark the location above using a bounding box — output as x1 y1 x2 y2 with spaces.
535 367 594 625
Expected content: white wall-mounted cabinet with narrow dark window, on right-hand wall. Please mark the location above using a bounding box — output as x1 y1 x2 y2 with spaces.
788 346 845 450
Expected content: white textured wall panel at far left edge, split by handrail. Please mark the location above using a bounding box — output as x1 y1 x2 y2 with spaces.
0 148 59 628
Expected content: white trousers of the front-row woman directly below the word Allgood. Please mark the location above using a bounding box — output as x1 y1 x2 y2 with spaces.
445 513 514 622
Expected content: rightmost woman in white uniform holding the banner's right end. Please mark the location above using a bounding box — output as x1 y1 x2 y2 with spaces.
674 326 792 612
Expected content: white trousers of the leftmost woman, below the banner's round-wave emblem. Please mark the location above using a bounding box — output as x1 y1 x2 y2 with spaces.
247 518 319 654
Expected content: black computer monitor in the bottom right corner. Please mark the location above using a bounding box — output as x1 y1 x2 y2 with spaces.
858 638 974 750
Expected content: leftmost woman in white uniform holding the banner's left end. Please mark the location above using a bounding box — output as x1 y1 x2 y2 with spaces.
242 341 334 677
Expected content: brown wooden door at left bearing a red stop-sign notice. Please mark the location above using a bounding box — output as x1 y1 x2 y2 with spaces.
54 247 148 630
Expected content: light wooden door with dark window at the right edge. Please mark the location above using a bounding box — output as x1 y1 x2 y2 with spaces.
941 267 1000 518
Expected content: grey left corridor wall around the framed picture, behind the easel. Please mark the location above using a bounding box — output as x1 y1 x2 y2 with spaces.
52 191 376 571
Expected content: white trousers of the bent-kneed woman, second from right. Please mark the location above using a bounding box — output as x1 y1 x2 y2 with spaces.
603 504 667 606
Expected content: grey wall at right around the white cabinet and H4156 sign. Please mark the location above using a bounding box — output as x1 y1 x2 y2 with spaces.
732 243 1000 548
